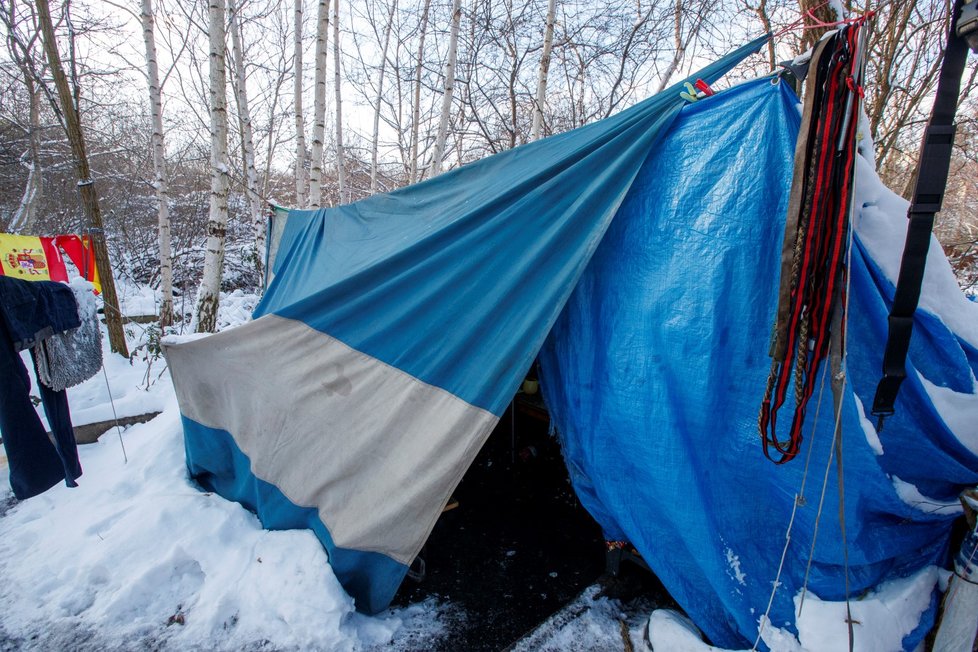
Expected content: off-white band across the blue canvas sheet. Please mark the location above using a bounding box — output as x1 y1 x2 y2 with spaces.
165 315 498 564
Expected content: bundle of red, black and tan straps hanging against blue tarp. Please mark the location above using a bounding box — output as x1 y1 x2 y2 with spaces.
758 15 869 464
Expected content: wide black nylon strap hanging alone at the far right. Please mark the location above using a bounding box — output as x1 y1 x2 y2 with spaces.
873 0 968 422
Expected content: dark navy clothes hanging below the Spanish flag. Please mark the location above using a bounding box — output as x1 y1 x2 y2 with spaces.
0 277 82 500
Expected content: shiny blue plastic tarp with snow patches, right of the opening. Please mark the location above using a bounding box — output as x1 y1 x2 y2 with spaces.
540 76 978 649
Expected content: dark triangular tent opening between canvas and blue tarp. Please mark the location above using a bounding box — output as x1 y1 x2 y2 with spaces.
394 392 675 650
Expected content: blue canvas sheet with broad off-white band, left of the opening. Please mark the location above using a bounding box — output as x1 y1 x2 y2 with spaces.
160 38 766 612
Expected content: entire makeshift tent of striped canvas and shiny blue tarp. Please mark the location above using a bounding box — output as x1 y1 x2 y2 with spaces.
166 34 978 644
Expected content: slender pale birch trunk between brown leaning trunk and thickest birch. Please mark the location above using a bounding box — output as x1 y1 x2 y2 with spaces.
140 0 173 326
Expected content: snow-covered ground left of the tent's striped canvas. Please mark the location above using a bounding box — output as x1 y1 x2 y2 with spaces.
0 292 451 650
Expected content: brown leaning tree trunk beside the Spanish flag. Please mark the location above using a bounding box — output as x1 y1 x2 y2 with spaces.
35 0 129 357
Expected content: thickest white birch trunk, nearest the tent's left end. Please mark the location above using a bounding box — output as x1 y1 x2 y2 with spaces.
195 0 228 333
